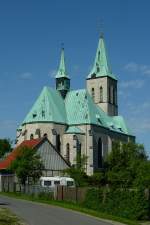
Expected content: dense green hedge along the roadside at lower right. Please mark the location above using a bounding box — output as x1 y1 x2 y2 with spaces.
83 188 150 220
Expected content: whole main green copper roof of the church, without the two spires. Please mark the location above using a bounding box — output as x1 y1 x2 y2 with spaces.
19 87 131 135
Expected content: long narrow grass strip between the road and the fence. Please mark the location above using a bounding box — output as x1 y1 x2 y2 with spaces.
0 192 141 225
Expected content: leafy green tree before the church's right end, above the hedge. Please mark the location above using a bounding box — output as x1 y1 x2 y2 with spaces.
105 142 148 187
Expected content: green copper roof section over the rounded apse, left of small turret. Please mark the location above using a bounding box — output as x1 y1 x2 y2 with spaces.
23 87 66 124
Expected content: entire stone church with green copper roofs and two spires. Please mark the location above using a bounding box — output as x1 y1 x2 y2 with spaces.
16 35 135 175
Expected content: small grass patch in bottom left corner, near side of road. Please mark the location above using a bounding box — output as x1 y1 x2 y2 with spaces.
0 207 22 225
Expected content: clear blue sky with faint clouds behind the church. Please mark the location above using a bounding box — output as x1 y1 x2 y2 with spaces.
0 0 150 153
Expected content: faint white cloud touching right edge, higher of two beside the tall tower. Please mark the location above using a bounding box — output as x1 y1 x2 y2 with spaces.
124 62 150 75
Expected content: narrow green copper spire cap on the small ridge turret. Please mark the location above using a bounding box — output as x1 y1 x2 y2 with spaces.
56 48 69 78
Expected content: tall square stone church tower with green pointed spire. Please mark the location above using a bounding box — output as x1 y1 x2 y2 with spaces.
87 34 118 116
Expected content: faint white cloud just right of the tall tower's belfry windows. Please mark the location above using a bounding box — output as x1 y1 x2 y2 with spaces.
120 79 145 89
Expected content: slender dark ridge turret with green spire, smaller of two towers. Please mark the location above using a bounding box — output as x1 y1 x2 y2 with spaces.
55 48 70 98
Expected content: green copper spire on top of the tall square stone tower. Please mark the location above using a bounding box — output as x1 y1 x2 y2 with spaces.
88 35 116 80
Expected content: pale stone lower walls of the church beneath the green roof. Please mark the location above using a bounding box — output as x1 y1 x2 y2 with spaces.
17 123 135 175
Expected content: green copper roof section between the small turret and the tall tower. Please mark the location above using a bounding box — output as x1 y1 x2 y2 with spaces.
65 89 107 126
